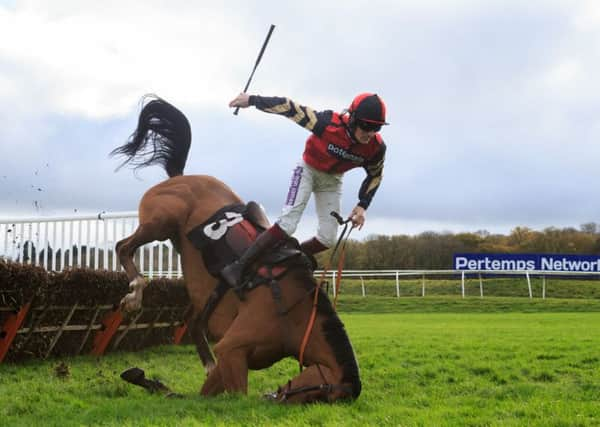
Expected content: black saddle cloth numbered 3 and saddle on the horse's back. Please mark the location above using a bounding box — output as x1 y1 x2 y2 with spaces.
187 202 313 298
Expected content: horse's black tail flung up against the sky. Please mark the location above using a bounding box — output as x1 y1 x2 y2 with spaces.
110 95 192 177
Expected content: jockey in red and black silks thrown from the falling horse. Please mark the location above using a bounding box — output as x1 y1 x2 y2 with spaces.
221 93 388 287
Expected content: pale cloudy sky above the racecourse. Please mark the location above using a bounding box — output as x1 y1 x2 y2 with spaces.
0 0 600 239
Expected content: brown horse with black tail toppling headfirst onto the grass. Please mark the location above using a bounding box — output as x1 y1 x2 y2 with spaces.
111 95 362 403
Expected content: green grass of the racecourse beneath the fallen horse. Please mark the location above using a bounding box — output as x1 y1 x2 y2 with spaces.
0 295 600 426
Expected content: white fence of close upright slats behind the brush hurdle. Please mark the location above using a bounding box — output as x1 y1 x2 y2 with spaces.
0 212 181 277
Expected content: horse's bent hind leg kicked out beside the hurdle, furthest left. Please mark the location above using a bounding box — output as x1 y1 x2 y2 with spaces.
116 220 169 311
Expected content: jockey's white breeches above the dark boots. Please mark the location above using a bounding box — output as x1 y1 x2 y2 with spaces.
276 161 343 247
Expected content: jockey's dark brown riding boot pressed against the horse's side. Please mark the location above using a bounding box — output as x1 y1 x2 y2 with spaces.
221 224 287 289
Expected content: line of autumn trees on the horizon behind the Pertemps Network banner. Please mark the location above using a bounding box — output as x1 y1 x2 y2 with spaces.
318 222 600 270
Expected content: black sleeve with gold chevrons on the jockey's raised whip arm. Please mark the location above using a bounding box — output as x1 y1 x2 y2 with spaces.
248 95 333 136
